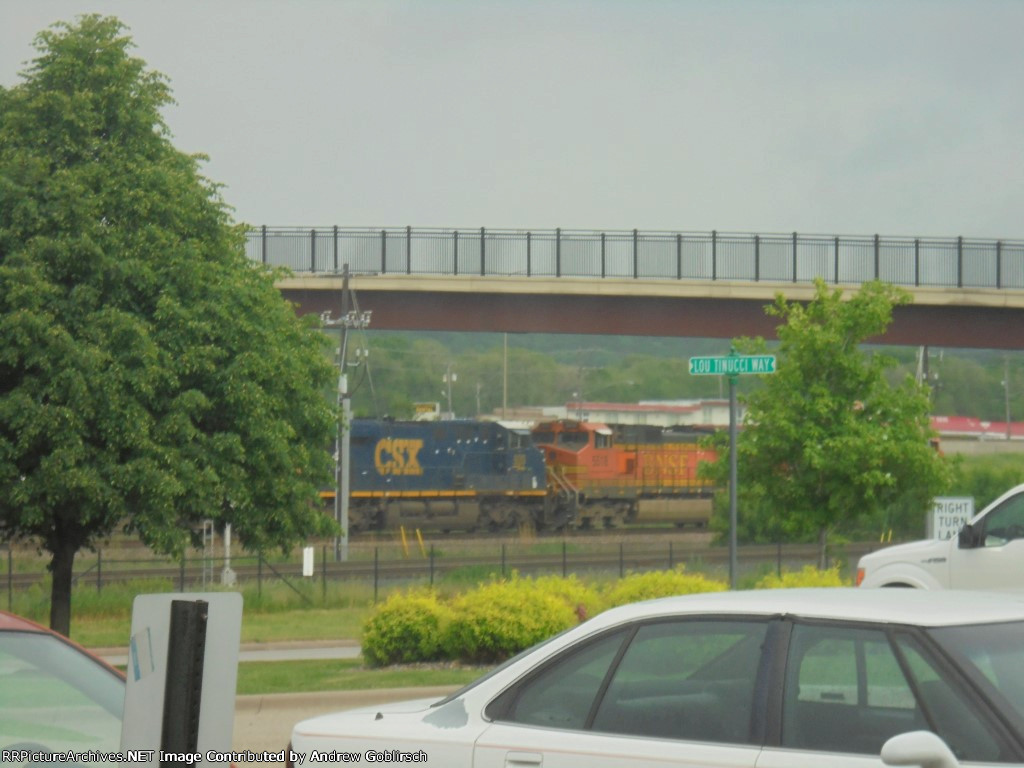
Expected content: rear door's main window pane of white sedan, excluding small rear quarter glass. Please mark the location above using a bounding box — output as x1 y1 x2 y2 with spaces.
592 621 768 743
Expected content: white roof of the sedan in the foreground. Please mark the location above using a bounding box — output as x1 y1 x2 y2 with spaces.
595 588 1024 627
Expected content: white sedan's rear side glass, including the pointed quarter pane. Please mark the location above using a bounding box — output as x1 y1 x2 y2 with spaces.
486 621 768 743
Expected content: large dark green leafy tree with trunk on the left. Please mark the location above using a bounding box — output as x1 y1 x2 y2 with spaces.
0 15 335 633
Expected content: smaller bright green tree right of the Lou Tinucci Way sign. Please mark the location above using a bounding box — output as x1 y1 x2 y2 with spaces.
713 281 949 557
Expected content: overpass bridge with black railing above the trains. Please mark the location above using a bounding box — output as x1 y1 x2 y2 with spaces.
247 226 1024 349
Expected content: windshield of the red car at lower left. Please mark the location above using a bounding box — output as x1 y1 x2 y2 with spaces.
0 632 125 762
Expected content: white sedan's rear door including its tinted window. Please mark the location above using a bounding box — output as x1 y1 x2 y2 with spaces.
473 618 768 768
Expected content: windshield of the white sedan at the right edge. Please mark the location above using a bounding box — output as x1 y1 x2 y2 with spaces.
930 622 1024 720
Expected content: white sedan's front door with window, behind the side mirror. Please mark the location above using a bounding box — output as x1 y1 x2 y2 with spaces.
757 623 1012 768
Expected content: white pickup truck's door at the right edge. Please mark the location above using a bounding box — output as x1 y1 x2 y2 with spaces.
949 493 1024 590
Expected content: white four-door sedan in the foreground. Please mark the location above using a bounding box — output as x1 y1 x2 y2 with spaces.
290 589 1024 768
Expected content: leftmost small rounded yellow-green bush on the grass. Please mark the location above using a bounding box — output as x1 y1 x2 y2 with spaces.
361 590 451 667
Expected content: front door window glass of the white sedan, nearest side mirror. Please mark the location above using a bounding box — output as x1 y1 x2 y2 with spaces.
782 624 927 755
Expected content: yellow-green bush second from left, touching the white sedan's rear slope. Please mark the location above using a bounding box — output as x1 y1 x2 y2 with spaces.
444 579 578 664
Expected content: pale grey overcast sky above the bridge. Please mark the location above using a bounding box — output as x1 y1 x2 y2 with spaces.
0 0 1024 239
